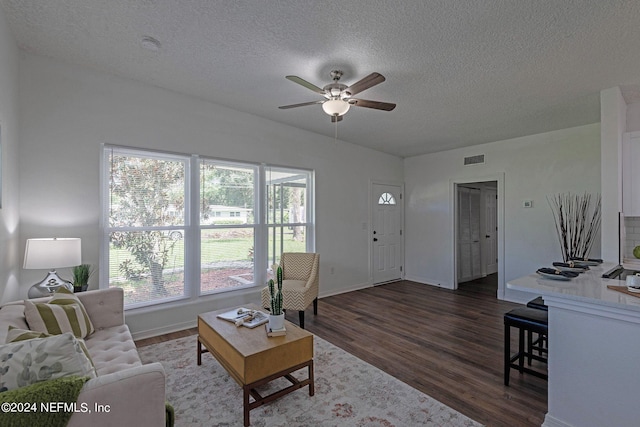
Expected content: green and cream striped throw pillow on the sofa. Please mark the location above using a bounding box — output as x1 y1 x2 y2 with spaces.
24 288 95 338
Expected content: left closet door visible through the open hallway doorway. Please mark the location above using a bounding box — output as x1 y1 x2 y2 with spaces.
458 186 482 283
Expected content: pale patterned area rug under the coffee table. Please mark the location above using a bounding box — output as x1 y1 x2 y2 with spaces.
138 336 480 427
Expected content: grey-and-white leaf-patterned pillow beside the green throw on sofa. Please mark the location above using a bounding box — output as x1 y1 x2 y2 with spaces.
0 333 96 391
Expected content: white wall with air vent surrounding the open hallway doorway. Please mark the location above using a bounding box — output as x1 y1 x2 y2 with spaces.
405 124 600 301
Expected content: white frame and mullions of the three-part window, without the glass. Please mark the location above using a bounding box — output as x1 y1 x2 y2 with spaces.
99 144 315 311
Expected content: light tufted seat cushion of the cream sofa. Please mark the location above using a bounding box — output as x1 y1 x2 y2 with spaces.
85 325 142 376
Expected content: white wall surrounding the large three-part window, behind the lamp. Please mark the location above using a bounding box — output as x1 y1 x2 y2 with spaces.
20 54 403 336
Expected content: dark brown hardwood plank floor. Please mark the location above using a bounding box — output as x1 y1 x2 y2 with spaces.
137 276 547 427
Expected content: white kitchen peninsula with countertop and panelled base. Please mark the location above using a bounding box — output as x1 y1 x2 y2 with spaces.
507 263 640 427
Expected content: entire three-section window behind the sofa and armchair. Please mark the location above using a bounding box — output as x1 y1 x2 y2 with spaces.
100 146 315 308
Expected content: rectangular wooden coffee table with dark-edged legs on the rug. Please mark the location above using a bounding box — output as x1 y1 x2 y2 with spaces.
198 304 315 426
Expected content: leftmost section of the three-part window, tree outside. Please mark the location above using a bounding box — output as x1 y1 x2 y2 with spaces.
104 149 189 305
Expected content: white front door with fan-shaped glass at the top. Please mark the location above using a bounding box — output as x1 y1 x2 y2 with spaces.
371 184 403 284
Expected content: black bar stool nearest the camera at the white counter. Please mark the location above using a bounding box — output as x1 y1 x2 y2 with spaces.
504 307 548 386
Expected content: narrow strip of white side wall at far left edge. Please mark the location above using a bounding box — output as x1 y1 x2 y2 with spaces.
0 4 21 302
